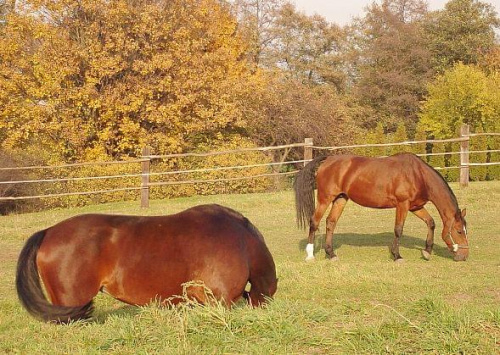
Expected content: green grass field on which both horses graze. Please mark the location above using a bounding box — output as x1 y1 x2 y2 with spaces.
0 182 500 354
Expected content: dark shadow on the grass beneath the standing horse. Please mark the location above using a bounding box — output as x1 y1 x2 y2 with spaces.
299 233 453 259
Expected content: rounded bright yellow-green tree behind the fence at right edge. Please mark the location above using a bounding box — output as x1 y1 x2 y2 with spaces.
419 63 500 138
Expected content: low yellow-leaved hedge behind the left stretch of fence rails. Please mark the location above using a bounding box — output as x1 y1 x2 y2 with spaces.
0 136 276 214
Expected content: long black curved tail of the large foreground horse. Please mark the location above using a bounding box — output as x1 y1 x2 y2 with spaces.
16 230 93 323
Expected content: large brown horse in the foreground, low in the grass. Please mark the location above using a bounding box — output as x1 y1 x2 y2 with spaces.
16 205 277 322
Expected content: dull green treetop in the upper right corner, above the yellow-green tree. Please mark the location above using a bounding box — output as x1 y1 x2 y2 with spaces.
424 0 500 72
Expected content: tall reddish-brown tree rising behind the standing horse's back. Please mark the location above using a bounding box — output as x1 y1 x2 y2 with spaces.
351 0 433 136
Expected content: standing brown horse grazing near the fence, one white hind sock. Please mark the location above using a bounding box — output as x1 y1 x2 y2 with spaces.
294 153 469 261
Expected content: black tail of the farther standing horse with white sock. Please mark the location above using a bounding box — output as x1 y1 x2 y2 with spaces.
293 156 327 229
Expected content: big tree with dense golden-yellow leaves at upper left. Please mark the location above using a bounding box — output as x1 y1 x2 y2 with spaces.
0 0 249 160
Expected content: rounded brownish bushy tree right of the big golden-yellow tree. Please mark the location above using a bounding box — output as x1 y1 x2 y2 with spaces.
243 74 357 161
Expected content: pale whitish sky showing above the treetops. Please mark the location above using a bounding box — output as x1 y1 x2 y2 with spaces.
290 0 500 26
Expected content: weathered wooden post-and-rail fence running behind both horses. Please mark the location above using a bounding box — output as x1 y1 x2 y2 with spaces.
0 125 500 207
